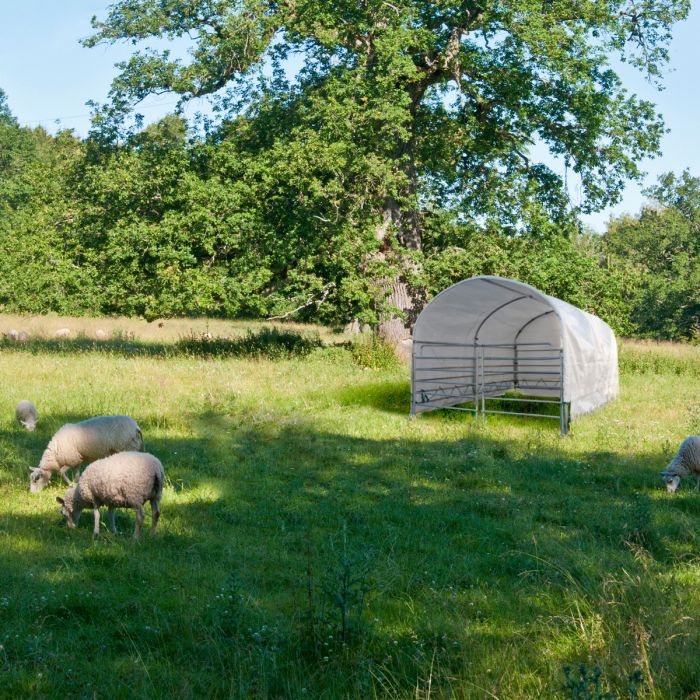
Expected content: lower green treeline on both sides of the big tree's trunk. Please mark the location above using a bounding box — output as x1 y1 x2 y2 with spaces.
0 91 700 339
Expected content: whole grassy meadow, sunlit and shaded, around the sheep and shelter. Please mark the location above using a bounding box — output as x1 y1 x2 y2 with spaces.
0 317 700 700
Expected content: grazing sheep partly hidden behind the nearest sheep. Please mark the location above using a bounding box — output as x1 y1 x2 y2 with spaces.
29 416 143 493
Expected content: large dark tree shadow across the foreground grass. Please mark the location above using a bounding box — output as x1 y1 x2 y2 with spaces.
0 412 700 698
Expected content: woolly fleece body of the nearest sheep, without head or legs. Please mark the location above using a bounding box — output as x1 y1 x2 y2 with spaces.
76 452 165 508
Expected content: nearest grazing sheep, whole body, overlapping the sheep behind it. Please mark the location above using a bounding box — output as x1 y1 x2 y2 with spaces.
56 452 165 540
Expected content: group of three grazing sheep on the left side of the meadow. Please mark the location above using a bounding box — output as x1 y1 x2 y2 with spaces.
15 400 165 539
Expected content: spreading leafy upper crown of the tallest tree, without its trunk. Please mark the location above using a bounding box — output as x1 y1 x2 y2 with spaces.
85 0 688 226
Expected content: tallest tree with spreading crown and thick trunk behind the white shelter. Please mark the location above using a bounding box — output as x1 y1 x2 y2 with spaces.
85 0 689 340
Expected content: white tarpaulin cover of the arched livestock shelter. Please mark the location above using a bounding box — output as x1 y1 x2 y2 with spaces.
412 276 619 417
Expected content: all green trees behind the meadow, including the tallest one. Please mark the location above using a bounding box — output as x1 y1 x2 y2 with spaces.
0 0 700 340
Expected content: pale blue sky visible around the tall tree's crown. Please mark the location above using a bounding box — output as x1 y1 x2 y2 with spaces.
0 0 700 232
